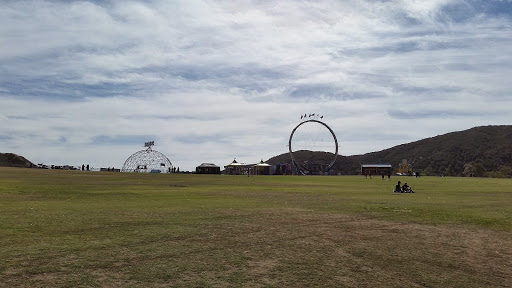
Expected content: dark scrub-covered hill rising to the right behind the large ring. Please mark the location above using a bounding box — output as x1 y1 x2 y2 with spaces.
267 125 512 177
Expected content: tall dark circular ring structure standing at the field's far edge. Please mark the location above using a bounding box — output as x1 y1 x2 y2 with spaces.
288 119 338 175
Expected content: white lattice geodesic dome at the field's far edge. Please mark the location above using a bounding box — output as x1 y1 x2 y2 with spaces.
121 147 172 173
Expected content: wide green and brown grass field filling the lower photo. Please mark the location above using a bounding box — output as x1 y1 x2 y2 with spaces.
0 168 512 287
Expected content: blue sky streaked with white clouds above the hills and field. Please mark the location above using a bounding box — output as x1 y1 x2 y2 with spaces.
0 0 512 171
